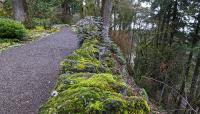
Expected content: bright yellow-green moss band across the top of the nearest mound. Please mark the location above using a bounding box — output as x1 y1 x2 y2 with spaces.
56 73 126 93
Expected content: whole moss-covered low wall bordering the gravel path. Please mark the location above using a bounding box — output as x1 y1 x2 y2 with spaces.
39 17 150 114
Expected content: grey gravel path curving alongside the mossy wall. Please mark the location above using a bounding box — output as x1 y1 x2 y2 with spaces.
0 28 78 114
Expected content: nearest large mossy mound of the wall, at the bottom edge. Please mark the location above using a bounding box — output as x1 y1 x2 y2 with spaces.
39 73 149 114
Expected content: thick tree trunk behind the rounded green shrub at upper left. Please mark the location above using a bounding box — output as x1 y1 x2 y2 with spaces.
12 0 27 22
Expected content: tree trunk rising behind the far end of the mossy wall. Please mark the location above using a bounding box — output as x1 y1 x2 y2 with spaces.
101 0 112 40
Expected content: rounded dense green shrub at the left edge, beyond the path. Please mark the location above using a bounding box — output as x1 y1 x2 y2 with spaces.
0 18 26 39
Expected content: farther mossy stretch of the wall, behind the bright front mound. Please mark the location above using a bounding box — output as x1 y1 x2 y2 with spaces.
61 38 114 74
